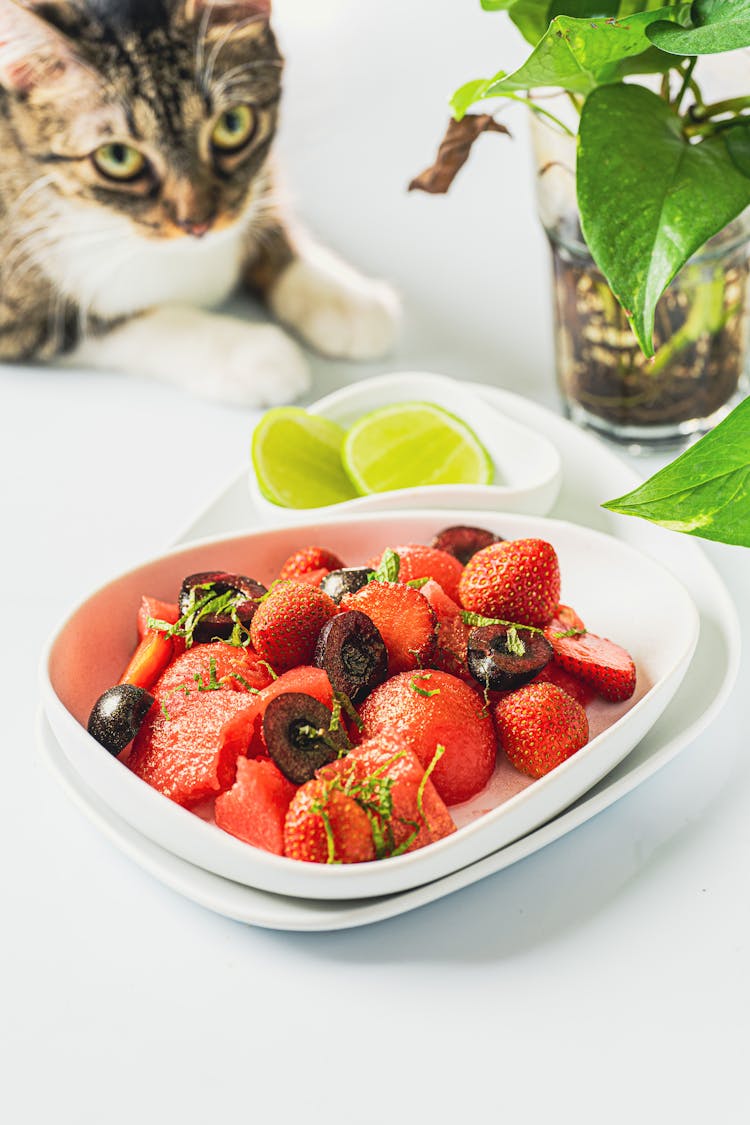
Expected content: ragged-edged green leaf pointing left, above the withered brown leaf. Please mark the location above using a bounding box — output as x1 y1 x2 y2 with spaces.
482 3 690 98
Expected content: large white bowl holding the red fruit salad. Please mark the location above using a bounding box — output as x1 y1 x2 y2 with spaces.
42 511 698 899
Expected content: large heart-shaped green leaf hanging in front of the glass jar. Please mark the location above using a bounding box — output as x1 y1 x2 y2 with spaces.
577 83 750 356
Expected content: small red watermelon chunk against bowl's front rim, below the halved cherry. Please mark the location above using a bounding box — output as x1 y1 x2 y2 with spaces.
215 758 297 855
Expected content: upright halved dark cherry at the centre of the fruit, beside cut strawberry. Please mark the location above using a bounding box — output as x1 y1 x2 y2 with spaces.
314 610 388 703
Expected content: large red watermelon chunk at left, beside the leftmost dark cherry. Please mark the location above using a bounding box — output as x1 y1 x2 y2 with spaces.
127 691 257 807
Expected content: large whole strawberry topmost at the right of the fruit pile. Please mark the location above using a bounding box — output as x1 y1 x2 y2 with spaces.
459 539 560 628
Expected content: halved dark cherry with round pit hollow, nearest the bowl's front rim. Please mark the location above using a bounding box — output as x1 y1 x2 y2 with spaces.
263 692 350 785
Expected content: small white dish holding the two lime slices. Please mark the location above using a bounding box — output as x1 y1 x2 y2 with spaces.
249 371 561 525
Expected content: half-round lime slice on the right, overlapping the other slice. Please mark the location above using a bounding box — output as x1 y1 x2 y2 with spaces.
341 403 495 495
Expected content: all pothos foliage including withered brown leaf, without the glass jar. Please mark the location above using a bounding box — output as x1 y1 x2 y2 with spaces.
412 0 750 546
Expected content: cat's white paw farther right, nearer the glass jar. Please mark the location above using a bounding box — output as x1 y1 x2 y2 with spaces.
269 248 400 360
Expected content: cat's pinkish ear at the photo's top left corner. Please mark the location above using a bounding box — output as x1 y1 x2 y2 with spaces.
0 0 88 93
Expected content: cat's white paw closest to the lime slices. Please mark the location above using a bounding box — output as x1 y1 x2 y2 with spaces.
186 317 310 407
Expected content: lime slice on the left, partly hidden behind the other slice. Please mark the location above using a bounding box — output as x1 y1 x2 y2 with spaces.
252 406 356 507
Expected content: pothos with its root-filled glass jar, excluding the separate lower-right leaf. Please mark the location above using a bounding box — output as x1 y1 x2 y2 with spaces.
412 0 750 449
